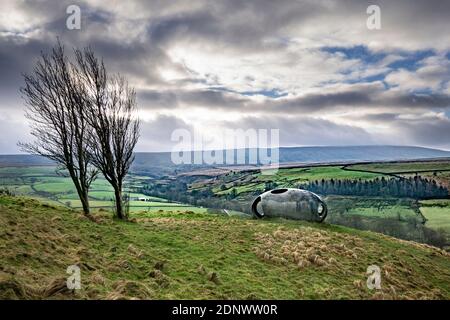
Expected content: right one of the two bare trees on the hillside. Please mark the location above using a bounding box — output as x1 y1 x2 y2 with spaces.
76 48 139 219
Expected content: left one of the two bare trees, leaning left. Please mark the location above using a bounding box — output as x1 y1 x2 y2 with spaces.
19 41 98 215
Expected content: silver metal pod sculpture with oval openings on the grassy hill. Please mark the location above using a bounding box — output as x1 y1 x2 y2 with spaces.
252 188 327 222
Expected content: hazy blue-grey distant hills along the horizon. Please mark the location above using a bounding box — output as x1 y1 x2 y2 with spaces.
0 146 450 176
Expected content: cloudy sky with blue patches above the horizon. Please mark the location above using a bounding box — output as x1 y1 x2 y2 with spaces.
0 0 450 154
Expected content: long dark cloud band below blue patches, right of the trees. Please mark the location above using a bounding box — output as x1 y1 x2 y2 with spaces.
140 87 450 114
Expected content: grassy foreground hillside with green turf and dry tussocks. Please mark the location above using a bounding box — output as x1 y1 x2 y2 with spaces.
0 196 450 299
